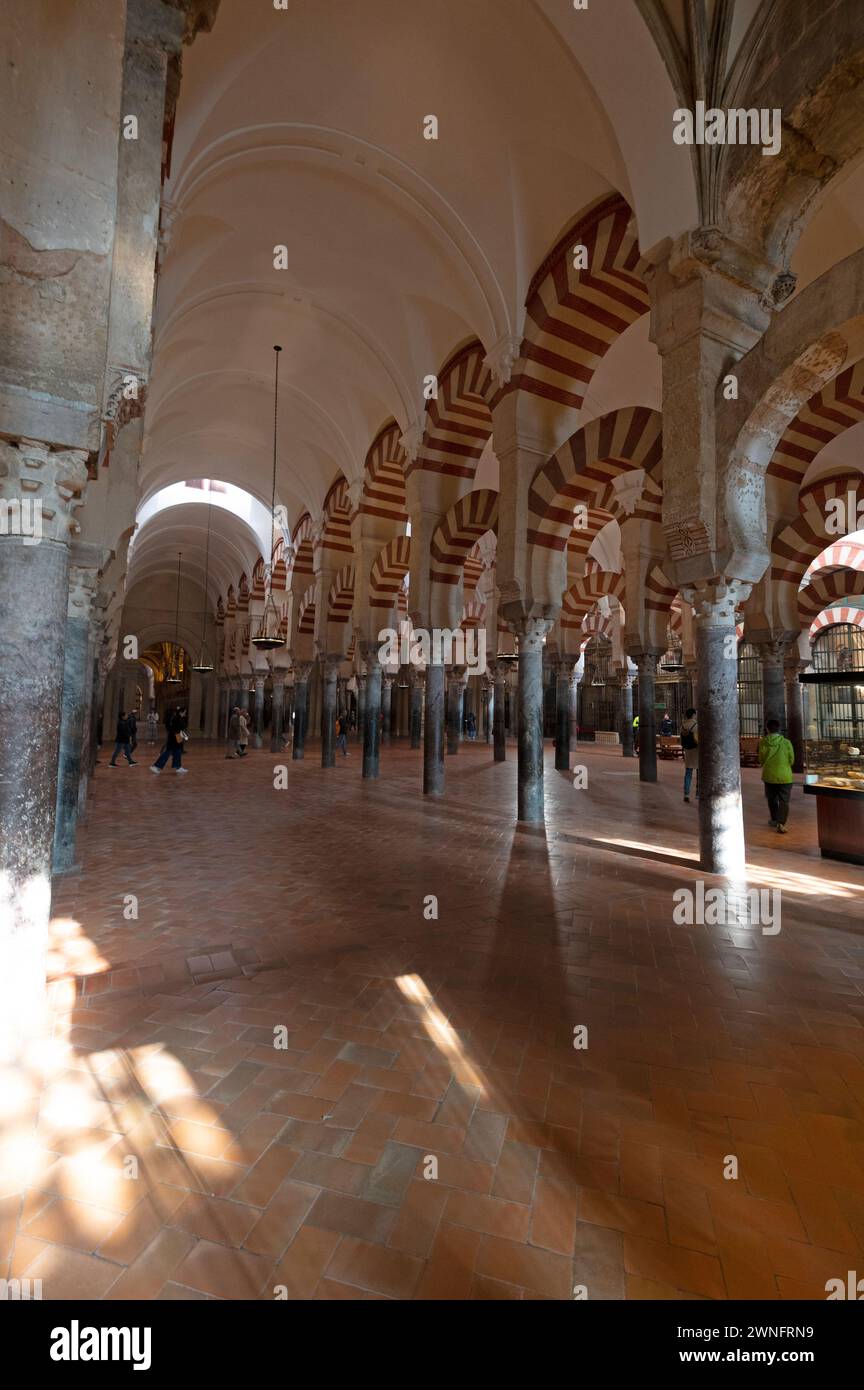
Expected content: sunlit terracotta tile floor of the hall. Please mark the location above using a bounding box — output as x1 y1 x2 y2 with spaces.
0 744 864 1300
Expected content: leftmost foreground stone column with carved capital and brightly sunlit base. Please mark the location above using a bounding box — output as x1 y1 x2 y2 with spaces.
0 439 88 1056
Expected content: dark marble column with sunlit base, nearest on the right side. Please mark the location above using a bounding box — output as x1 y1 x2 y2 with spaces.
683 580 750 880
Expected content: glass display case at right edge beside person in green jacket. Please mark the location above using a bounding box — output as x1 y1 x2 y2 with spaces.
799 670 864 863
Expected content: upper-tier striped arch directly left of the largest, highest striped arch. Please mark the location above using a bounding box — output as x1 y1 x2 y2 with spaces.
419 339 492 478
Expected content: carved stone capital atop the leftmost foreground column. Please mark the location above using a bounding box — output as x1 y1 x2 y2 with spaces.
0 439 88 545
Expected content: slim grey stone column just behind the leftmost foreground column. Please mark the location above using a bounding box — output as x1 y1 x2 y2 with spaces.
53 564 97 873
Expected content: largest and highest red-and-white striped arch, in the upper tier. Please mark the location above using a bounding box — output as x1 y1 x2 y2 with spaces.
513 193 649 410
